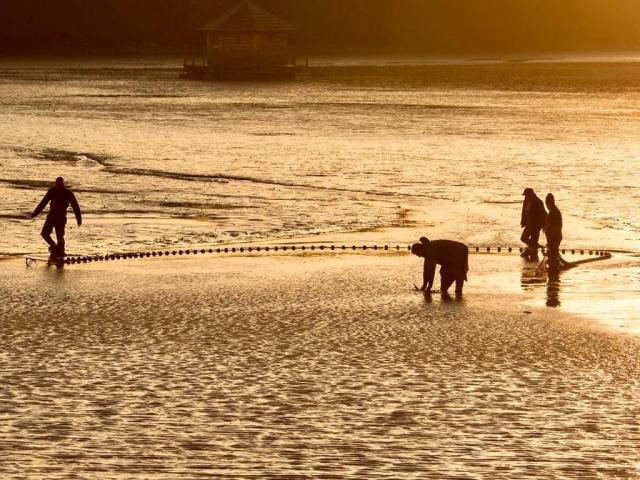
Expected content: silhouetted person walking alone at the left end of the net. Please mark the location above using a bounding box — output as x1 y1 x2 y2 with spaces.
31 177 82 256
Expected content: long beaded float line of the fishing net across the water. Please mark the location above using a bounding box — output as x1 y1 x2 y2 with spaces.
64 245 611 265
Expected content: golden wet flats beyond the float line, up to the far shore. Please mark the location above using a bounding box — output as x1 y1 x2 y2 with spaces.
0 59 640 254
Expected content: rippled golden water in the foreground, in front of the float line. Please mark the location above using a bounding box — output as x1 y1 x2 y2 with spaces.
0 251 640 480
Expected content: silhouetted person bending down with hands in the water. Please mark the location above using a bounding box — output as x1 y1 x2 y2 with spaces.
411 237 469 297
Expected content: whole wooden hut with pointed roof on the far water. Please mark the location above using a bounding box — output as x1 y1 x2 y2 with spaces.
184 0 296 80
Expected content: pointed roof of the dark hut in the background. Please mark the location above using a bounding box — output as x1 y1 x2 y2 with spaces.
200 0 296 33
